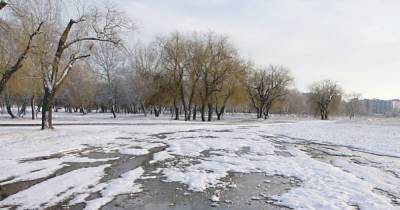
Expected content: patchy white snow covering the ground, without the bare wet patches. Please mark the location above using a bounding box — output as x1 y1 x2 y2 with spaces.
0 114 400 210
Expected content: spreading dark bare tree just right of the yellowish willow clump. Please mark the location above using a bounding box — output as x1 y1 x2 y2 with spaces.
247 65 293 119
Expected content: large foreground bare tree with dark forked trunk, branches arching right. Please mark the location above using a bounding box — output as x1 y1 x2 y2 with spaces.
38 2 129 129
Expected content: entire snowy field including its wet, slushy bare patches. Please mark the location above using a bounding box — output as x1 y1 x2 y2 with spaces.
0 114 400 210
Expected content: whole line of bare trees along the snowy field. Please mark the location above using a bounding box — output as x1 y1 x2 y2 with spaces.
0 0 368 129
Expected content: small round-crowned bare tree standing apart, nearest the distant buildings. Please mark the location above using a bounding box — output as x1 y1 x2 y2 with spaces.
310 80 342 120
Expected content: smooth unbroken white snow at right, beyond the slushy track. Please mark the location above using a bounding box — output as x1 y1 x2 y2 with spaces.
262 121 400 156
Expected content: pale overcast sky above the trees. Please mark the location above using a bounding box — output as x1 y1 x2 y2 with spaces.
113 0 400 99
